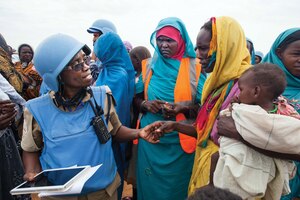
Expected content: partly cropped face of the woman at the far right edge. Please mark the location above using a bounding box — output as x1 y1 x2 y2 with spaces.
277 40 300 78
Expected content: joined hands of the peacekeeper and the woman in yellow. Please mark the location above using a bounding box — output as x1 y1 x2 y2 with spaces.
139 121 176 144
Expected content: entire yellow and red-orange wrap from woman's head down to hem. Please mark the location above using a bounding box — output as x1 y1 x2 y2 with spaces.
189 17 250 195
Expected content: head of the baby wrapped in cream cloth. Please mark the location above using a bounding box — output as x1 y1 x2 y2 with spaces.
238 63 287 106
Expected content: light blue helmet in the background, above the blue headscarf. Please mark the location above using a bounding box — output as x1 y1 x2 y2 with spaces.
87 19 117 34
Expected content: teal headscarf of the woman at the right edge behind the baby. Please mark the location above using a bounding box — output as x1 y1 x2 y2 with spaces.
262 28 300 100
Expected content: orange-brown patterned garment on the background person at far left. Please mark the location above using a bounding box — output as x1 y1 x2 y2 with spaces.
15 62 42 101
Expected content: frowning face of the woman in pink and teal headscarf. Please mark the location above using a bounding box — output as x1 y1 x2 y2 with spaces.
156 35 178 58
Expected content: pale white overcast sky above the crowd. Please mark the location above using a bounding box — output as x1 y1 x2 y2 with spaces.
0 0 300 54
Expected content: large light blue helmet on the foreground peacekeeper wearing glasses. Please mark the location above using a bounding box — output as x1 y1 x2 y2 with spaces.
33 34 91 92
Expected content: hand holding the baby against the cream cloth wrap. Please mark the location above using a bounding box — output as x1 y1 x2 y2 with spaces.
217 115 242 141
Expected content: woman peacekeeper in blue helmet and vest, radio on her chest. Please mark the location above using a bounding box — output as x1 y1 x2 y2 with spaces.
21 34 158 199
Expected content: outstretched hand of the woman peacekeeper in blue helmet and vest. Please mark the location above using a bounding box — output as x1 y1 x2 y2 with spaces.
139 121 163 144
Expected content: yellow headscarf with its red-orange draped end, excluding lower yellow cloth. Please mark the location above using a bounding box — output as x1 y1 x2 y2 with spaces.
196 17 250 146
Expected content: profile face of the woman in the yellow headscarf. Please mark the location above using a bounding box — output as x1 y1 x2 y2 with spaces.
196 28 215 73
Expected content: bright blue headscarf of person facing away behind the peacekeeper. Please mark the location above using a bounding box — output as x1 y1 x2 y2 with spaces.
94 32 135 126
